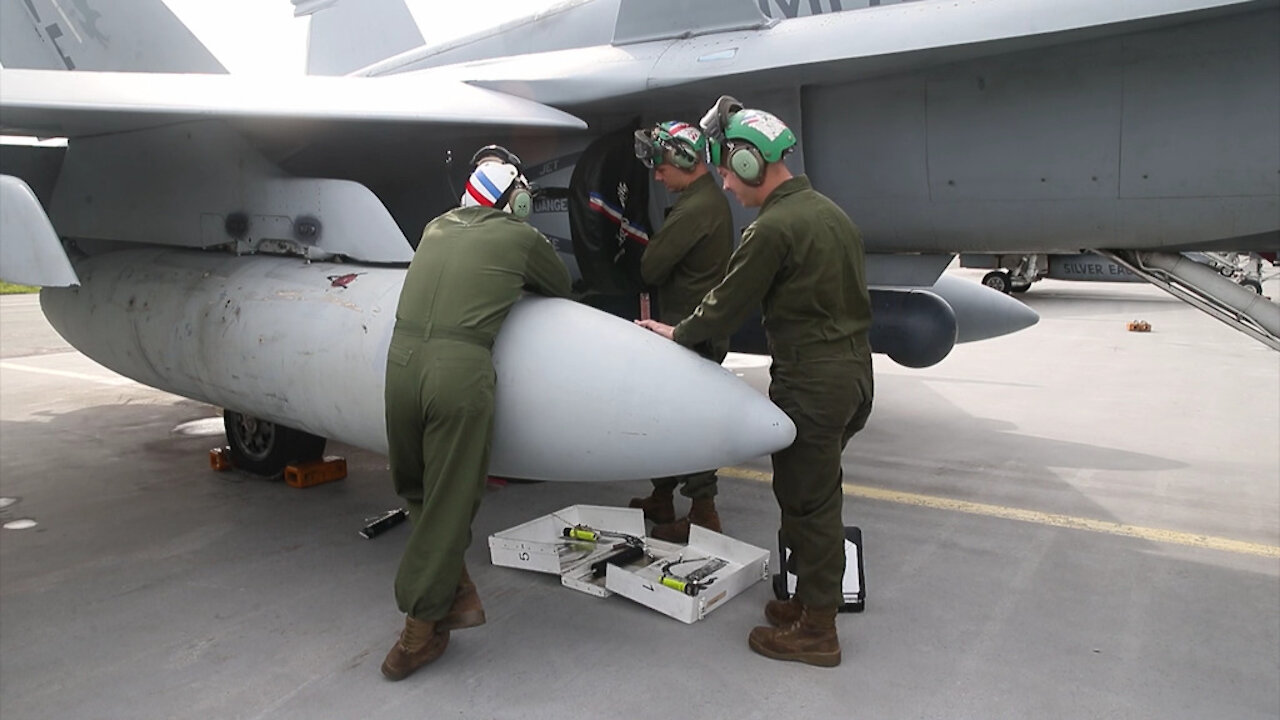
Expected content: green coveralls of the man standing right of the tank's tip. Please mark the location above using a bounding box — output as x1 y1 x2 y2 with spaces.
675 176 873 607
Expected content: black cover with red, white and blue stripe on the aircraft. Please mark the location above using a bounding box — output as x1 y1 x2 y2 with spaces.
568 127 650 303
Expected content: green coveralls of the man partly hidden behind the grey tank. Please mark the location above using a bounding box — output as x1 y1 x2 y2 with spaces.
640 173 733 498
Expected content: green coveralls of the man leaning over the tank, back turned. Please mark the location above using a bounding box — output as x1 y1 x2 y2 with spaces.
385 208 570 621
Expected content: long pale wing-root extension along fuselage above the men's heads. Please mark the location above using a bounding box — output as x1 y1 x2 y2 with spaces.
428 0 1265 106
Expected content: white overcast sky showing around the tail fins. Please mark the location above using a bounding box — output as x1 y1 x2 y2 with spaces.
165 0 557 74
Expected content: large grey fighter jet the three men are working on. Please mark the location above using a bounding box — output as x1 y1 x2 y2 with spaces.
0 0 1280 479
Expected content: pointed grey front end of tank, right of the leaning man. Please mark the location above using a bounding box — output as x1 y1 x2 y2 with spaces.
490 297 795 480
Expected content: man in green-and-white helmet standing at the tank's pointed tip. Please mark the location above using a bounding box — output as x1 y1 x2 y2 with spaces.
640 96 873 666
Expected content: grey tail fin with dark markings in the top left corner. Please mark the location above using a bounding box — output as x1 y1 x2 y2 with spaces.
0 0 227 73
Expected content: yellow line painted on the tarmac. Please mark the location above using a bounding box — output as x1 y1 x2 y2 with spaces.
719 468 1280 559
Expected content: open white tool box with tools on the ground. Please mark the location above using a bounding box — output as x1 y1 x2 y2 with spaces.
489 505 769 623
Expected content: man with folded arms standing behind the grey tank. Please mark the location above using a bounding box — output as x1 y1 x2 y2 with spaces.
630 122 733 543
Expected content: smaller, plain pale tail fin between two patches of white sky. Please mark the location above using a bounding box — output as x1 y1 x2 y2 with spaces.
293 0 422 76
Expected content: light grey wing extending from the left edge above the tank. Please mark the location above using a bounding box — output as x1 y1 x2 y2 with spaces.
0 68 586 137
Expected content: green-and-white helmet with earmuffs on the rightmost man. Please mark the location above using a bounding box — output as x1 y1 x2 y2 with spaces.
701 95 796 184
